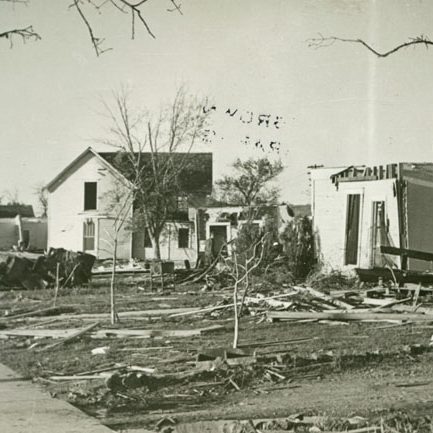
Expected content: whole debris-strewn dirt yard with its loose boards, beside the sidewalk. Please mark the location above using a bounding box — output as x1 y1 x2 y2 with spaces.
0 276 433 432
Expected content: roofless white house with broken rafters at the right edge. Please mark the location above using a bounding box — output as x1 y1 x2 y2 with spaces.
311 163 433 271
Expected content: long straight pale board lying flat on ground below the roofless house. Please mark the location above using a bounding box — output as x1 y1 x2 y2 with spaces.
266 311 433 322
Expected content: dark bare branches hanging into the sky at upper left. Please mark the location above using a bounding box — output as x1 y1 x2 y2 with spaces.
0 0 183 56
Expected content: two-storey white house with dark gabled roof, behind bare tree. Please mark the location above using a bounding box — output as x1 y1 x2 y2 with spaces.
46 148 212 262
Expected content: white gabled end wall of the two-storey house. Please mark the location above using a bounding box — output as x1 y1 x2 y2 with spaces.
48 153 131 259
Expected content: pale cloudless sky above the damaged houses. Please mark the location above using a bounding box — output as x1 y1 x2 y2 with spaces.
0 0 433 214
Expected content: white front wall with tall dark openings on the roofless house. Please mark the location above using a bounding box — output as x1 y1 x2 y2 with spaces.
311 168 399 270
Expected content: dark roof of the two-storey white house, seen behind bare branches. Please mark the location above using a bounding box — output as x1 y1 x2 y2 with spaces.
99 152 213 194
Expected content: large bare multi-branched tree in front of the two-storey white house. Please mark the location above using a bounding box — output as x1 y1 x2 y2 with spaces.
105 88 207 259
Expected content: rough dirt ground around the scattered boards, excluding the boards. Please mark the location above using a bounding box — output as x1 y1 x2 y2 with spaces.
0 277 433 431
